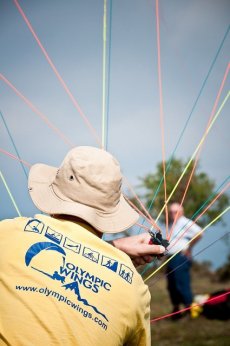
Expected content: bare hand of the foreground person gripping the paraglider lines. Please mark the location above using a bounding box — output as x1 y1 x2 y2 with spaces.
112 233 165 266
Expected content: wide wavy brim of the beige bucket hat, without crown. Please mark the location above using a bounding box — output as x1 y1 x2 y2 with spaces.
28 164 139 233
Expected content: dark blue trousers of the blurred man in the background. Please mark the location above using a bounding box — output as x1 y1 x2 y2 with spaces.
167 253 193 306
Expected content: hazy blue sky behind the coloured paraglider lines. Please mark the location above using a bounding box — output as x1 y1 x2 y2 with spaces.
0 0 230 267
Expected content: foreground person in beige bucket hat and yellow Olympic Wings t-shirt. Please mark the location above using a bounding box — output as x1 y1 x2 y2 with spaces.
0 147 165 346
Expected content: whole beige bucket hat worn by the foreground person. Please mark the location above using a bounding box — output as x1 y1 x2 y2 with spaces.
29 146 139 233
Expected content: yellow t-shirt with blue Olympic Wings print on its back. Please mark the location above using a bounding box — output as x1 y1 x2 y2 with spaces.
0 215 150 346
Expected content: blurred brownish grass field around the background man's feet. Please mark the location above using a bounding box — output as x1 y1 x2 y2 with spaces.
142 264 230 346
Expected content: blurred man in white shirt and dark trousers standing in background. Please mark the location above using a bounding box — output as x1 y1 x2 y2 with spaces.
166 203 201 319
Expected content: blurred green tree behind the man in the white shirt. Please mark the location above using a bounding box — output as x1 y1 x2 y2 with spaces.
140 159 229 226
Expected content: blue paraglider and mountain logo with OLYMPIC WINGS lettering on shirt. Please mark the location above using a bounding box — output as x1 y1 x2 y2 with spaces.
25 242 108 321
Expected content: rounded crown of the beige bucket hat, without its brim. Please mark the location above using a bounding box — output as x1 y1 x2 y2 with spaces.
52 147 122 212
